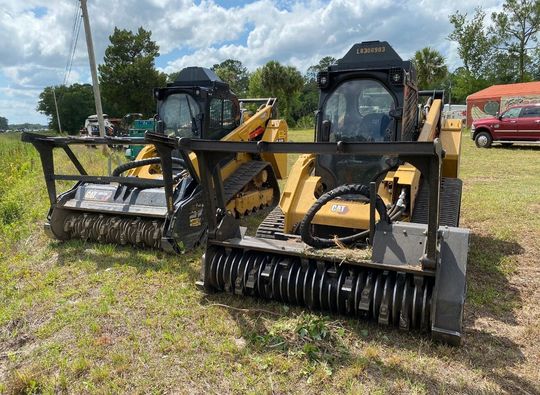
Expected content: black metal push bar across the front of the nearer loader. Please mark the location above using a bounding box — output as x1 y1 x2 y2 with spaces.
145 132 444 269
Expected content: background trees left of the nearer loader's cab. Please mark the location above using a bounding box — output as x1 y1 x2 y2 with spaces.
37 27 335 134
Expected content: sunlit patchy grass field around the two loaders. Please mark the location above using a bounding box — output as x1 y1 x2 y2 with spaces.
0 131 540 394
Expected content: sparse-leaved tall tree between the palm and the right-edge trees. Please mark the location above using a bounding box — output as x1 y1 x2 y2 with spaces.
448 7 495 78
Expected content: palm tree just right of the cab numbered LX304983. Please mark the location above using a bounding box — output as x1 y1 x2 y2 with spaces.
413 47 448 89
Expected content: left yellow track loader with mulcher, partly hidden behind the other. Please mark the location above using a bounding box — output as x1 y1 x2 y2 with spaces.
22 67 288 252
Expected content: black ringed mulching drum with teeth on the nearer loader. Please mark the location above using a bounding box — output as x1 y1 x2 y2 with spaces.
205 248 433 331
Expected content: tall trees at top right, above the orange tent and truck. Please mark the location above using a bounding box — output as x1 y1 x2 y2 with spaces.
448 0 540 101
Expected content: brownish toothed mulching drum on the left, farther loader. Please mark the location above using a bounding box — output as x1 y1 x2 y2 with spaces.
64 213 163 248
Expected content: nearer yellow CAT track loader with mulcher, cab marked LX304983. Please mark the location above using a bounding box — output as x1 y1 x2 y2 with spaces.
148 41 469 344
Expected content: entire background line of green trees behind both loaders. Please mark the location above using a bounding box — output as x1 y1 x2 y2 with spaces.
37 0 540 133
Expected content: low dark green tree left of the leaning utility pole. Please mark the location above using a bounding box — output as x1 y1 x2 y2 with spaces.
37 84 96 134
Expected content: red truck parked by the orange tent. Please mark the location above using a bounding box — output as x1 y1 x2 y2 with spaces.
471 103 540 148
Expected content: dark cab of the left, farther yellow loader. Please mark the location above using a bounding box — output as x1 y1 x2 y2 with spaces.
154 67 240 140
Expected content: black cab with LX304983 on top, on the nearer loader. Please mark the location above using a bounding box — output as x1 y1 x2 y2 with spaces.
315 41 418 190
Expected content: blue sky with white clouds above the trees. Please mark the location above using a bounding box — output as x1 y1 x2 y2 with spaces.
0 0 502 124
